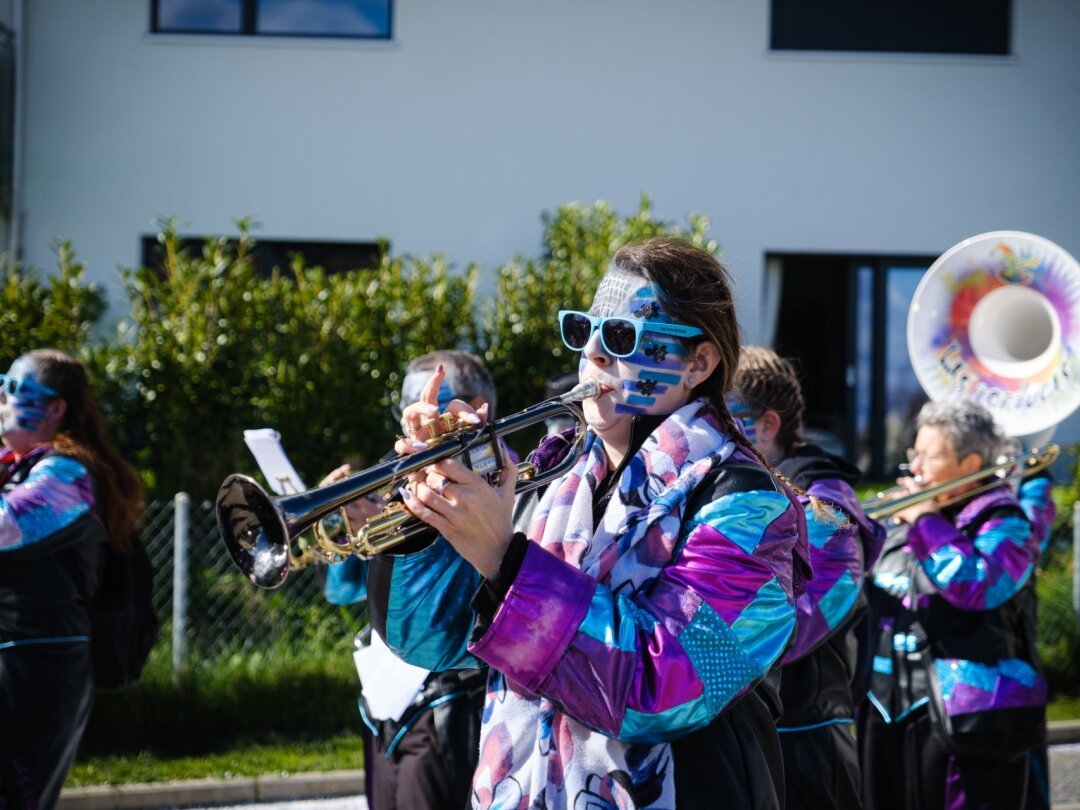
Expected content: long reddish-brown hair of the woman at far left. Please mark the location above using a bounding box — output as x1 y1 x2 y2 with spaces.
25 349 143 551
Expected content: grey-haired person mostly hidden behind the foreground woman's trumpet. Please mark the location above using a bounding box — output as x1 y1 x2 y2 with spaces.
322 350 494 810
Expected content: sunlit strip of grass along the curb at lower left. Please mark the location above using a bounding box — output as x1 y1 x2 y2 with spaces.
66 733 364 787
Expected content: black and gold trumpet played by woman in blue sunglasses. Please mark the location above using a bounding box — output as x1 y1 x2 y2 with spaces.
216 382 600 588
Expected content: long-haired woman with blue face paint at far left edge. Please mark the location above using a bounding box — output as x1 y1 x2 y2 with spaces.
0 349 141 808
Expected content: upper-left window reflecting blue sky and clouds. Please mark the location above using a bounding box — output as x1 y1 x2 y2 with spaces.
150 0 391 39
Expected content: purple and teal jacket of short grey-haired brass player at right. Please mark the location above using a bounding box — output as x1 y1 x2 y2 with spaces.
868 486 1052 734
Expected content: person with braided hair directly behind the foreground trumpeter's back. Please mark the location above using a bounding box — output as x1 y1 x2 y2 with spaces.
730 346 885 810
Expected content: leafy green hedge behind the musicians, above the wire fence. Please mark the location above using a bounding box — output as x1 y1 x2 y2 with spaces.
0 195 717 499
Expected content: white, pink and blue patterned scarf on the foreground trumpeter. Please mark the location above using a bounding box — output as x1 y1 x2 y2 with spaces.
474 400 735 809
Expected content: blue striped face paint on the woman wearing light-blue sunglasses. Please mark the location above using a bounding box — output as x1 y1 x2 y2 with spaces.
579 269 690 415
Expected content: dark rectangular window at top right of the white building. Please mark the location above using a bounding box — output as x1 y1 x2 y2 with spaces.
769 0 1012 55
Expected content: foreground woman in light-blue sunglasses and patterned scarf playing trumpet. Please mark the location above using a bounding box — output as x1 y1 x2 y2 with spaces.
368 239 809 808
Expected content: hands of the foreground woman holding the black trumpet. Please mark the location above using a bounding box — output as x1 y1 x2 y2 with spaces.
394 365 517 577
